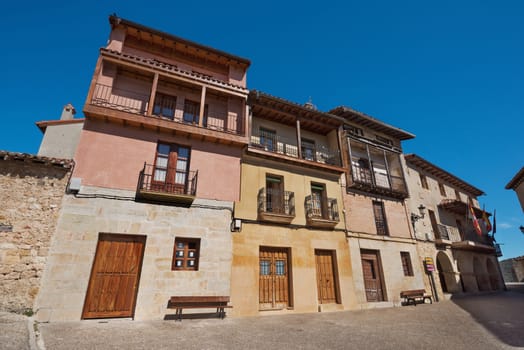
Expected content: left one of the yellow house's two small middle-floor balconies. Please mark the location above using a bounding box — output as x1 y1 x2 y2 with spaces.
258 188 295 224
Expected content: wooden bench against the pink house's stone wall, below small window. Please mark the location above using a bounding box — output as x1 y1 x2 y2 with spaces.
167 296 233 321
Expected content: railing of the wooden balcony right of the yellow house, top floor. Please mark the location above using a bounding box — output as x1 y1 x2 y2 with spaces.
350 164 407 197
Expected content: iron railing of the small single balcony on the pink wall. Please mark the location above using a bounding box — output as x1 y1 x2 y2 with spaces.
138 164 198 196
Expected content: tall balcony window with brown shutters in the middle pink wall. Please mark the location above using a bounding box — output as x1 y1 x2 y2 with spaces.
151 143 190 193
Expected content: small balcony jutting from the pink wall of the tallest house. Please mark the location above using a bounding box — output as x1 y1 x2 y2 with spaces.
136 164 198 205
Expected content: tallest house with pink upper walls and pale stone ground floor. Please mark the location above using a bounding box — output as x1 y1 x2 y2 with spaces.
36 16 250 321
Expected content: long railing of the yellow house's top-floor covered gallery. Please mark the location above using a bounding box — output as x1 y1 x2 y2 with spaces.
250 131 341 166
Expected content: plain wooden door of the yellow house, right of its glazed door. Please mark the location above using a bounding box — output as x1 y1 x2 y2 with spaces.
315 250 339 304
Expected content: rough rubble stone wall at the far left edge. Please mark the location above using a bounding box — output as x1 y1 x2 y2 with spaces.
0 157 69 312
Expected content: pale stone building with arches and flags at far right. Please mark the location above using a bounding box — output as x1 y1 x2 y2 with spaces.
404 154 504 297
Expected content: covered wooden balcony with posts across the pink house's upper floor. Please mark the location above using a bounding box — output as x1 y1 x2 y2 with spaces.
84 49 248 145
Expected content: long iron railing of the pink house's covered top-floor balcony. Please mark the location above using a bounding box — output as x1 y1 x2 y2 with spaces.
91 84 244 135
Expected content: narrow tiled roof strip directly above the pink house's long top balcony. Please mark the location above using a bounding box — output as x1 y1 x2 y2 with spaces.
100 48 251 93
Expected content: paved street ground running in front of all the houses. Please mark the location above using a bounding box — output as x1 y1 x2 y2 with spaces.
4 291 524 350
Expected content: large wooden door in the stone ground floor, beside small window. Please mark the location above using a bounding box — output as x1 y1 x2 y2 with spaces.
82 234 146 319
